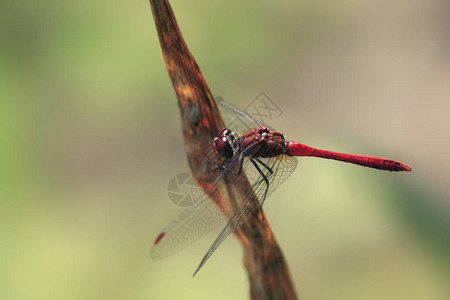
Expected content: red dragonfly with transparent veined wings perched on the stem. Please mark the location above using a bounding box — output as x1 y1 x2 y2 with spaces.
151 99 411 276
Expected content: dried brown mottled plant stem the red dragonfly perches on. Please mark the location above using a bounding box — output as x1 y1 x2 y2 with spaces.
150 0 297 299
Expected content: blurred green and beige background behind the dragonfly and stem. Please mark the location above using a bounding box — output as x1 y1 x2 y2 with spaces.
0 0 450 300
